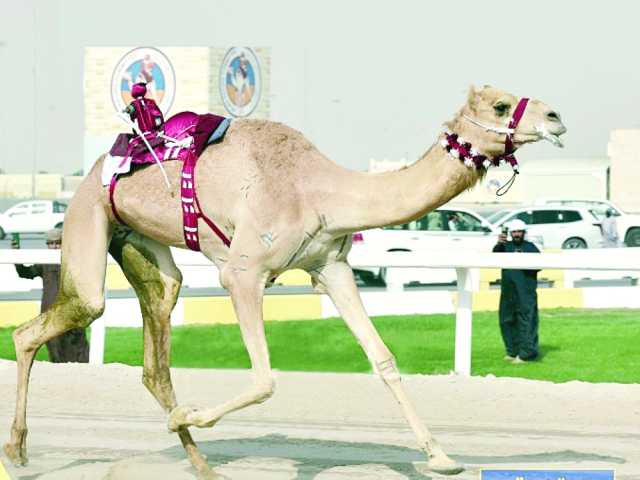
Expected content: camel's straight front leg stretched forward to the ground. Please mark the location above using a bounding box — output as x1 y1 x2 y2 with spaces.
310 262 464 475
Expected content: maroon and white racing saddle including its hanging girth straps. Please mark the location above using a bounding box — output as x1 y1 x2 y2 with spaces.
101 112 231 251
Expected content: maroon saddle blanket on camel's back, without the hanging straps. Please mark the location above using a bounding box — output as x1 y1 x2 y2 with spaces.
109 112 231 165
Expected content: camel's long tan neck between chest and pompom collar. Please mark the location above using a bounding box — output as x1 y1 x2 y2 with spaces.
330 137 481 232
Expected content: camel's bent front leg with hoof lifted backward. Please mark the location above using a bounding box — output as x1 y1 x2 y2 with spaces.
169 255 275 431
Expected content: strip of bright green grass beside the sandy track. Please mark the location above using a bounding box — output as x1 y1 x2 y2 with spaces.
0 309 640 383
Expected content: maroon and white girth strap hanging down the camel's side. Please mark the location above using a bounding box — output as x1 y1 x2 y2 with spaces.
180 151 231 252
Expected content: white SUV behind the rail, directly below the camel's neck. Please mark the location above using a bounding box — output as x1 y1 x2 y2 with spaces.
349 208 498 284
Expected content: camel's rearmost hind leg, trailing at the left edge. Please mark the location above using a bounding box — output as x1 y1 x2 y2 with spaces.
4 183 111 465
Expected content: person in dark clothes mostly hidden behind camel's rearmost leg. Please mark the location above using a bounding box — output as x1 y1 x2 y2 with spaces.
11 228 89 363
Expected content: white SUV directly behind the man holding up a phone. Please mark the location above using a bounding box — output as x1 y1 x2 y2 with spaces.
489 205 602 248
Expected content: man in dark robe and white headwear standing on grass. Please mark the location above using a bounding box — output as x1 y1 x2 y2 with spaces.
493 220 540 363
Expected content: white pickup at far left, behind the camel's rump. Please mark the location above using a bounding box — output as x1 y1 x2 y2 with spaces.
0 200 67 240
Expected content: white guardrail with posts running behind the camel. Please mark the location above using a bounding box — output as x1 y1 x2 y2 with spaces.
0 247 640 375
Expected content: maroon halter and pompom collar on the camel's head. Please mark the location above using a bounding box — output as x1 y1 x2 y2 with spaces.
440 98 529 173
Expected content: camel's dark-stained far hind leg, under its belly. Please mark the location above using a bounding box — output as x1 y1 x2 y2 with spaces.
109 232 220 479
